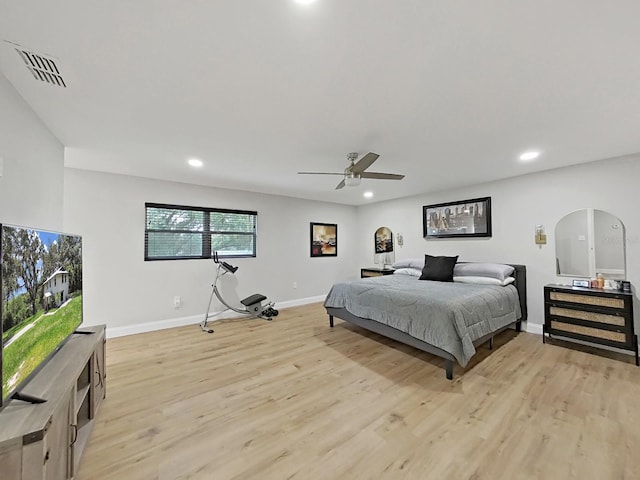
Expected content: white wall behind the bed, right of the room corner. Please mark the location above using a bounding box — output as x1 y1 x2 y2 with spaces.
358 155 640 331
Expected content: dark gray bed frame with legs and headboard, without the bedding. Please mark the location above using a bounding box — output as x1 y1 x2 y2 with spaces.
326 264 527 380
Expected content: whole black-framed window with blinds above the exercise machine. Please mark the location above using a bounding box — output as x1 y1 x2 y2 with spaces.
144 203 258 260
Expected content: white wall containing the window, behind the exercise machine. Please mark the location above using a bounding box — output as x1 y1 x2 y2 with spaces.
64 168 360 335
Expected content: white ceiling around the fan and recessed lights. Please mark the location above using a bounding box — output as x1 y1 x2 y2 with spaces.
0 0 640 205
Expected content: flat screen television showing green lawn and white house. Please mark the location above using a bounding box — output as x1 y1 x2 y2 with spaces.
0 224 82 408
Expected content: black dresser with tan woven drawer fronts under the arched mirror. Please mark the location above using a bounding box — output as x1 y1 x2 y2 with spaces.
542 285 640 365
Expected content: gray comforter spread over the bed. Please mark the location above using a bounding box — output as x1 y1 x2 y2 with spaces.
324 275 521 367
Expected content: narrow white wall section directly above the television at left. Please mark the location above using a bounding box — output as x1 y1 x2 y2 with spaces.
0 74 64 230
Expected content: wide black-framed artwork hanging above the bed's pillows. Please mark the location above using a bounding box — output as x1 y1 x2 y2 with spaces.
422 197 491 239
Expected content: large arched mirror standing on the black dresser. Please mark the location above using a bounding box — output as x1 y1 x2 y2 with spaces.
555 208 626 280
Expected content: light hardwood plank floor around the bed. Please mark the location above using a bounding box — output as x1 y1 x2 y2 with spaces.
77 304 640 480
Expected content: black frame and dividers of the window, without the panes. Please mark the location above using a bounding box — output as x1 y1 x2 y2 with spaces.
144 202 258 262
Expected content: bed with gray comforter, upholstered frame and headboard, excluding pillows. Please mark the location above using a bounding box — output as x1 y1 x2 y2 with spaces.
324 263 527 380
